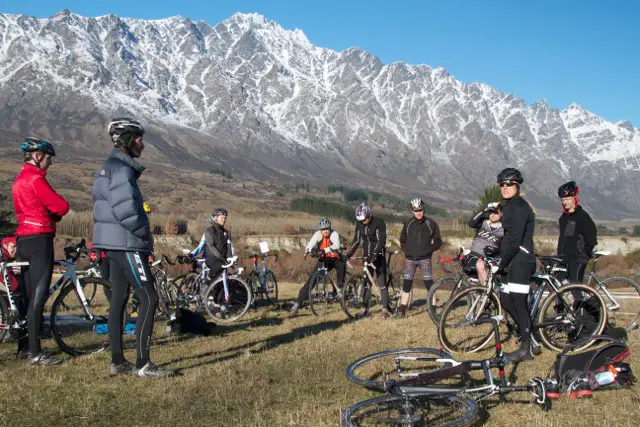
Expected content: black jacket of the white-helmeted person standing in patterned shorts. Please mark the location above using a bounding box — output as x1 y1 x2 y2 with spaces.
400 216 442 261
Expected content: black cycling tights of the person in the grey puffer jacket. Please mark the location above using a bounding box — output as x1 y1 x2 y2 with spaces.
107 251 158 369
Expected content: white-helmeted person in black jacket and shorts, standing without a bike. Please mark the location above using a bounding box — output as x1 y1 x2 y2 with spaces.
394 199 442 317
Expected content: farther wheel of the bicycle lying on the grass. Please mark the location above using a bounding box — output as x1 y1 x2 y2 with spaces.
345 348 468 392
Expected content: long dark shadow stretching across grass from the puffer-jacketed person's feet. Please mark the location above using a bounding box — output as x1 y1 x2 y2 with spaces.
162 319 348 371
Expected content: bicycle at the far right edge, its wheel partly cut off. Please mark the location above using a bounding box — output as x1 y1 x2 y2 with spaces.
584 251 640 332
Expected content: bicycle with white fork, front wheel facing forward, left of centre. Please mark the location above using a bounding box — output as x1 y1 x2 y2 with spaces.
204 255 253 323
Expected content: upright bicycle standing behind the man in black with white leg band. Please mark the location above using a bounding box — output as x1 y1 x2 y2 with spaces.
438 255 607 352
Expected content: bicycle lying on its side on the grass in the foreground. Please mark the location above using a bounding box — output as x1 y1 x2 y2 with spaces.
341 316 557 427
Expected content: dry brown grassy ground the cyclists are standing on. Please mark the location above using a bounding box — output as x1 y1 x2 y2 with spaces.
0 284 640 427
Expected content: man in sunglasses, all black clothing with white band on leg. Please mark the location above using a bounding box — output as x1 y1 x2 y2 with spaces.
497 168 536 362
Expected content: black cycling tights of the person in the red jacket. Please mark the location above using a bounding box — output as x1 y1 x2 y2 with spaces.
16 234 53 356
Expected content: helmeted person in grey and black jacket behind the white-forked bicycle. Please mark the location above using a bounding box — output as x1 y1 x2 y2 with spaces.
204 208 233 282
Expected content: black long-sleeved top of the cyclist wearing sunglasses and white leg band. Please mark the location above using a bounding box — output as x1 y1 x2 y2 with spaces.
500 195 536 269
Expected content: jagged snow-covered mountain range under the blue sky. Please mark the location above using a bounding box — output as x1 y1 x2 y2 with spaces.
0 10 640 217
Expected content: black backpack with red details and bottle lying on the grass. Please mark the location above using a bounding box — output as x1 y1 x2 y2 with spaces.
553 335 635 392
